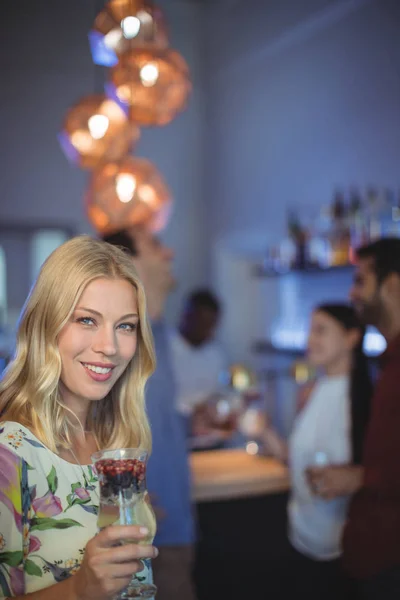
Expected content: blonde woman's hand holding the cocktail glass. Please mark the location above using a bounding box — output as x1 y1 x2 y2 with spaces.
72 525 158 600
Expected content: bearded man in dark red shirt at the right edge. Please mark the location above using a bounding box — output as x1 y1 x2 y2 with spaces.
314 238 400 600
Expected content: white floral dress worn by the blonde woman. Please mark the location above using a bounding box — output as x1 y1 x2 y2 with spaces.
0 422 99 598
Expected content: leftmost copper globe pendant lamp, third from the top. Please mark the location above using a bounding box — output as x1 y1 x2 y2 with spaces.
58 94 140 169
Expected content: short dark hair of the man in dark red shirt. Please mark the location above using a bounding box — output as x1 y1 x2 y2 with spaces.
356 238 400 283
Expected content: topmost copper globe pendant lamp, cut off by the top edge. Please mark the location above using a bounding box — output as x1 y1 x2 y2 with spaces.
89 0 169 67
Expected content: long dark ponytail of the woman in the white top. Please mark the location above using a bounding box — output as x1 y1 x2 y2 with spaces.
315 304 373 464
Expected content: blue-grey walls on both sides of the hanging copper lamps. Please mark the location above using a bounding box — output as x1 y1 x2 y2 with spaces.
0 0 400 342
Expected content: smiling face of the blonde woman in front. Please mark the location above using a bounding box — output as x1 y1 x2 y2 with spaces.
58 279 139 406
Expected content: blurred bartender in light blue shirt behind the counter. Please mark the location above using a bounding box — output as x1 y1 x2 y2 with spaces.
171 289 227 416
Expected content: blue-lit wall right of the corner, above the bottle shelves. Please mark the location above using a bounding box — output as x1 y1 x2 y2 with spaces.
207 0 400 359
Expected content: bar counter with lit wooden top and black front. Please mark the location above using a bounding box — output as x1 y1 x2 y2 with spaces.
191 450 289 600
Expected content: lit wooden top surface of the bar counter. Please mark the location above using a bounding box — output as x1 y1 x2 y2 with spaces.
190 449 289 502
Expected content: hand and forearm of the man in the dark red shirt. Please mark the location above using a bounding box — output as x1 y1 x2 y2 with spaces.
306 465 364 500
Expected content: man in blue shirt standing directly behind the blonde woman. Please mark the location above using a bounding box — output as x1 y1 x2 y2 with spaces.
104 228 195 600
